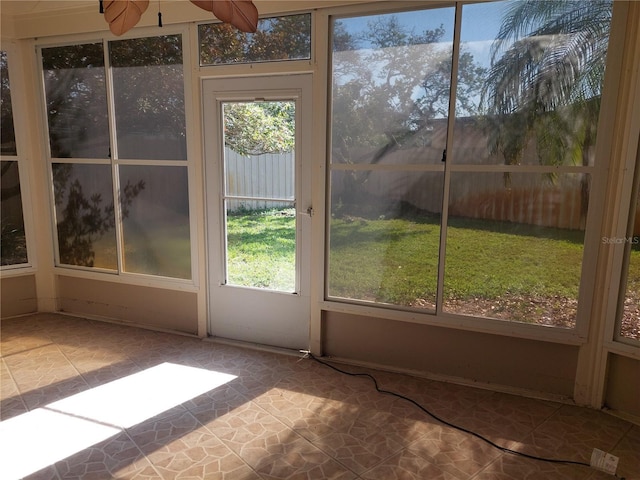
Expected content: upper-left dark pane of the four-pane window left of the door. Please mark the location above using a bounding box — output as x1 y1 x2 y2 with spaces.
42 43 110 158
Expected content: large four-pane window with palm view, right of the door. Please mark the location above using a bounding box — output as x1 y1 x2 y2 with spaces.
327 0 612 328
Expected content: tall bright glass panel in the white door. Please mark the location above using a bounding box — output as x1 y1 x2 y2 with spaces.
222 101 296 292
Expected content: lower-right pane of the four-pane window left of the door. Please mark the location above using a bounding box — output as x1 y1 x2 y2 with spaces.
120 165 191 279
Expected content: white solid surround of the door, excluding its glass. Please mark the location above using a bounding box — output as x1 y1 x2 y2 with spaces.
201 73 313 349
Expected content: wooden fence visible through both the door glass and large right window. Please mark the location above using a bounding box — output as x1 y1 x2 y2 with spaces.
225 148 586 229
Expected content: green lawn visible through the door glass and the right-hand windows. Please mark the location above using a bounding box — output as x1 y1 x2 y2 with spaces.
227 210 640 324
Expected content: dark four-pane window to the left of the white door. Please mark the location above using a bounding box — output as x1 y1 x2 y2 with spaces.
42 35 191 279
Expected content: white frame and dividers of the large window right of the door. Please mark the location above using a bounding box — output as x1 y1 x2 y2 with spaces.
320 1 625 346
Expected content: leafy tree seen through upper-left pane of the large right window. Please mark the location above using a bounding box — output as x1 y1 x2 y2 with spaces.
332 15 484 163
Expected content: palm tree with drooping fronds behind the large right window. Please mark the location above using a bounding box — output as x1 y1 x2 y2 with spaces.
482 0 612 223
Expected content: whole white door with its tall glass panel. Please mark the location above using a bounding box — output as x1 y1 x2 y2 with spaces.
202 75 313 349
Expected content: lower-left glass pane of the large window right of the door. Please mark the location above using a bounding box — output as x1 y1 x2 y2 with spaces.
329 171 443 310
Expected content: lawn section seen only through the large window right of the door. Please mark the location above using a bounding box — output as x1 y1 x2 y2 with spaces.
330 215 582 305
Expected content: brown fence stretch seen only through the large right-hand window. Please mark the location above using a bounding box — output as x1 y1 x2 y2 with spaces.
331 170 588 229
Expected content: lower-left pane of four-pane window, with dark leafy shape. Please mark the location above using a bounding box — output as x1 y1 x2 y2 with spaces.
52 163 118 270
